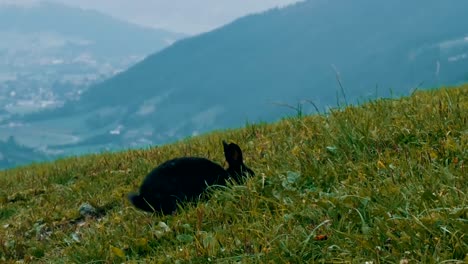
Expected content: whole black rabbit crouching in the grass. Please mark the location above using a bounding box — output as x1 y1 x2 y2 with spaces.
128 141 254 214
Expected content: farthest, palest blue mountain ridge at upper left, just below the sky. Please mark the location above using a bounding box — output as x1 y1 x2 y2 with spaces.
0 2 184 56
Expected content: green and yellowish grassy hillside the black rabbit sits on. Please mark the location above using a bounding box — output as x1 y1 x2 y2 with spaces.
0 85 468 263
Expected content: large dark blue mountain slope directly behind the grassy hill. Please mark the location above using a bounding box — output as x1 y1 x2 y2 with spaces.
7 0 468 163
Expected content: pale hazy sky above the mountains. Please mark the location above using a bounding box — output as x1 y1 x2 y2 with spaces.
0 0 298 34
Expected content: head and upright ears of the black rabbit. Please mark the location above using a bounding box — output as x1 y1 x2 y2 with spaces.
223 140 255 180
